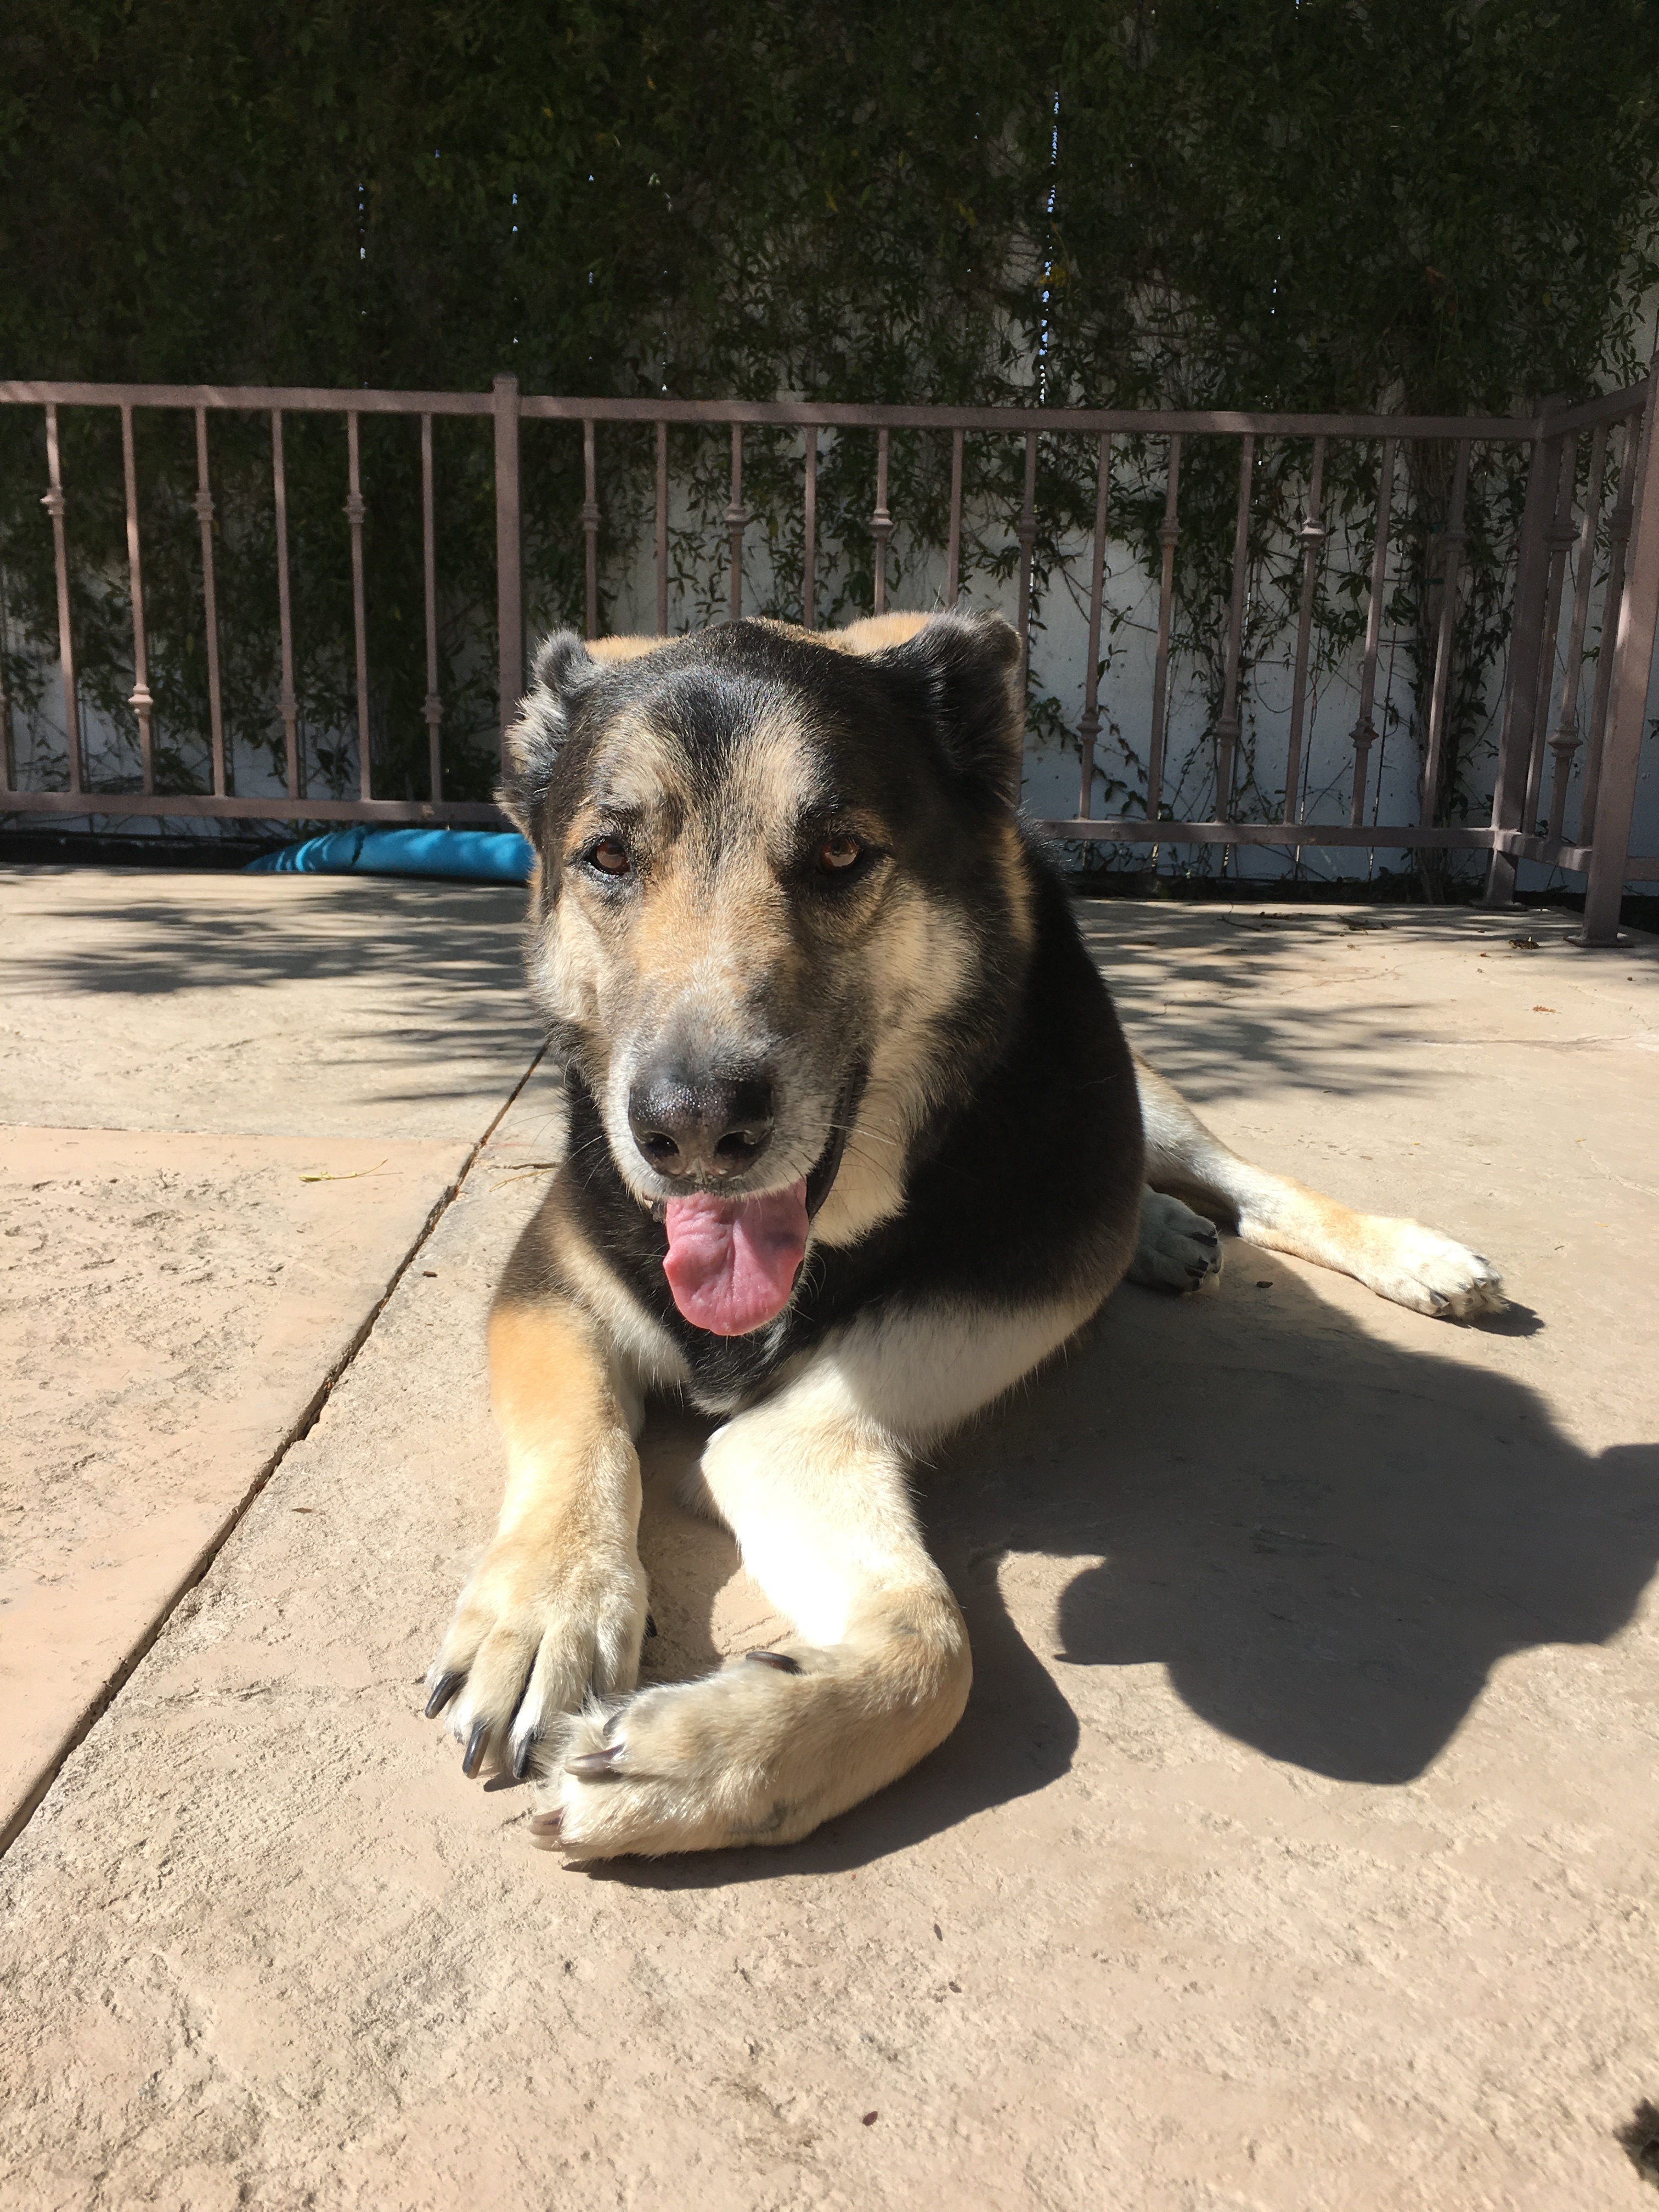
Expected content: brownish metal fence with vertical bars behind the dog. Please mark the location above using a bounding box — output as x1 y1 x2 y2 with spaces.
0 376 1659 945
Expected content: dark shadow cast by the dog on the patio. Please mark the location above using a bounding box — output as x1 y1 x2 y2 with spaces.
593 1248 1659 1887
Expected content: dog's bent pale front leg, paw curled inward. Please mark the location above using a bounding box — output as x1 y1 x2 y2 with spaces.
533 1305 1106 1858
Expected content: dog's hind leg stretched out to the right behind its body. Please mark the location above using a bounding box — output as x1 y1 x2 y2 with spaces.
1130 1053 1504 1321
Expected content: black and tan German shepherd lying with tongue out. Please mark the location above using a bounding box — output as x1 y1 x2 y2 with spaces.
427 613 1504 1860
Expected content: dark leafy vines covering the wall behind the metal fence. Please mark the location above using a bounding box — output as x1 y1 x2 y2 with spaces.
0 0 1659 832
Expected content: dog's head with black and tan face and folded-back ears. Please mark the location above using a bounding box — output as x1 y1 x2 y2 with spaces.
502 615 1031 1334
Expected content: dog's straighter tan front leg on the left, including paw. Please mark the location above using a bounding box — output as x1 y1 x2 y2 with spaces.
427 1299 646 1774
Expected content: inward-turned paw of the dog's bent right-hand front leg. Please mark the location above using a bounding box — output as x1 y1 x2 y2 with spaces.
531 1652 832 1858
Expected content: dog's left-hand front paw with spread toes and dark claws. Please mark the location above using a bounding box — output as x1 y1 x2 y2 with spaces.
427 1535 646 1776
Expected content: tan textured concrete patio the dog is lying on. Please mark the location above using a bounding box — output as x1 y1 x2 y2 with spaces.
0 870 1659 2212
